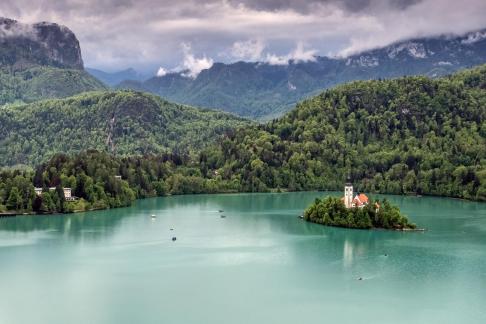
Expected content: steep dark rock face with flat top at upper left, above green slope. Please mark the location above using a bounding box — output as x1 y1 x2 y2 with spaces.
0 18 83 71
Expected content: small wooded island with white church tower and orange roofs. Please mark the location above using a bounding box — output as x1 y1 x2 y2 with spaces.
304 183 417 231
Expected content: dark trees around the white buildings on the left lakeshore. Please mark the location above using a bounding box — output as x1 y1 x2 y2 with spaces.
0 150 240 213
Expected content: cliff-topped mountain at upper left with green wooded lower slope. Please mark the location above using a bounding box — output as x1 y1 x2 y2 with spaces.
0 18 106 105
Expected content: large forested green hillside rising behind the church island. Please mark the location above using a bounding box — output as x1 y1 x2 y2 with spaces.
200 66 486 200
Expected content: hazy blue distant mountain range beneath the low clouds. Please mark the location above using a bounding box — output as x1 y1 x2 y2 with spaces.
118 30 486 119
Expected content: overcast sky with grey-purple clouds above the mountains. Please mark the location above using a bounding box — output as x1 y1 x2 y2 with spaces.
0 0 486 75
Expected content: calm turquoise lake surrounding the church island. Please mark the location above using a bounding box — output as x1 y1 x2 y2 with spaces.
0 192 486 324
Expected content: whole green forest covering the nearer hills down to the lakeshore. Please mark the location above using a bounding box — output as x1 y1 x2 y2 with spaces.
0 66 486 212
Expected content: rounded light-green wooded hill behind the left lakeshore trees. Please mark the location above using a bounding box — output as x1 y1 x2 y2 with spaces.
0 91 250 166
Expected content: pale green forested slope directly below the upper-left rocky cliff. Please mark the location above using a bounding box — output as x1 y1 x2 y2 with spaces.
0 66 106 105
